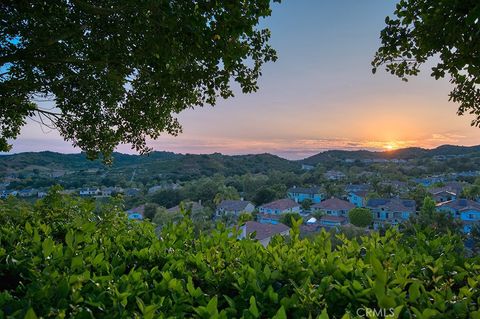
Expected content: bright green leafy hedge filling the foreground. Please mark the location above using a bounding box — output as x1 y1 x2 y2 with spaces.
0 190 480 318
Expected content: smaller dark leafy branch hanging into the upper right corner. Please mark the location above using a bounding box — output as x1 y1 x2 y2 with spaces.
372 0 480 127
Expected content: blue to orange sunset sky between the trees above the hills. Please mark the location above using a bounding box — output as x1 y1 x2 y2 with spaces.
6 0 480 159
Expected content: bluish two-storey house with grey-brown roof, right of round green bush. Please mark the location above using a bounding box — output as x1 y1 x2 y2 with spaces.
366 198 416 229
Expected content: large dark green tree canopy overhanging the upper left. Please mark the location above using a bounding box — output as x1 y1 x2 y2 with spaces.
0 0 279 158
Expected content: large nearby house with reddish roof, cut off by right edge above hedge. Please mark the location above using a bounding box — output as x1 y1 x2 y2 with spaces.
436 198 480 233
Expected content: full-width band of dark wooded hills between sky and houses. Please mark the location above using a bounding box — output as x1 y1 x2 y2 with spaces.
0 145 480 195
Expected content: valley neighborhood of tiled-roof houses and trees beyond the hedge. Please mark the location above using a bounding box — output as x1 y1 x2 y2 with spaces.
0 145 480 242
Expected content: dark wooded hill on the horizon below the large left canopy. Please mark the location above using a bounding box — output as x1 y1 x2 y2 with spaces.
0 152 301 180
